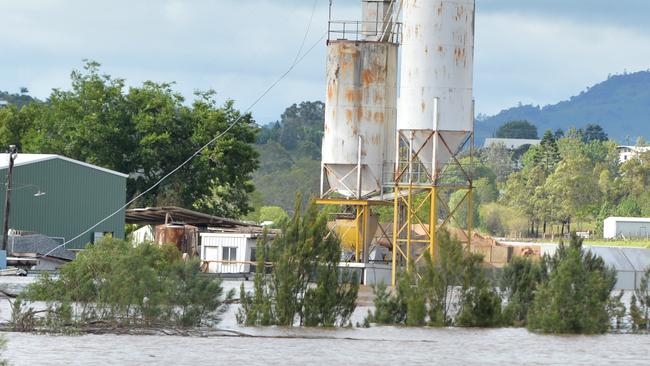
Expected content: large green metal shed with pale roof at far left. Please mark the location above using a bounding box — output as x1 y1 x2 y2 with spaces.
0 154 128 249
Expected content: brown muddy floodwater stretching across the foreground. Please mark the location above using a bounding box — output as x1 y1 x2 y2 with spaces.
0 284 650 366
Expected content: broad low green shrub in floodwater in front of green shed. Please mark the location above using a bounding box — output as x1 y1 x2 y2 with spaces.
23 238 233 327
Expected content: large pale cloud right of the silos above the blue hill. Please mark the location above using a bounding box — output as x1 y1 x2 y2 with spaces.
475 12 650 114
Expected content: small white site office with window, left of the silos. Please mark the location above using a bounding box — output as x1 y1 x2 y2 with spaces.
201 233 257 273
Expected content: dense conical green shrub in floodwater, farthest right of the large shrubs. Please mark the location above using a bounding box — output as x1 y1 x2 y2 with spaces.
527 234 616 334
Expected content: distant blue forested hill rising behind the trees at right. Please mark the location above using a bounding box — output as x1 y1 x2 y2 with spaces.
476 71 650 145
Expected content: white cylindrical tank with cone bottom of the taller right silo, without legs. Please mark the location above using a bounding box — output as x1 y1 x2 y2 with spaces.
397 0 474 176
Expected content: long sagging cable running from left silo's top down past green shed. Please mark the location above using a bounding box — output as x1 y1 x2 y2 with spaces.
39 27 327 258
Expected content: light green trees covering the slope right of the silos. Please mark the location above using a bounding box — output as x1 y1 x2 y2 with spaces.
474 120 650 237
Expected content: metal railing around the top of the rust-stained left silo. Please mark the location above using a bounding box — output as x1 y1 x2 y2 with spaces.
327 20 402 44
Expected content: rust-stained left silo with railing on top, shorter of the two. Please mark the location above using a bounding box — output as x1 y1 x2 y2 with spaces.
321 0 398 199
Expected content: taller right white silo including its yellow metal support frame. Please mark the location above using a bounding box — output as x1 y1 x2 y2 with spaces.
392 0 474 284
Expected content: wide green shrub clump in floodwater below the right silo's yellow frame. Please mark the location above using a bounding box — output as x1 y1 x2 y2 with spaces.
368 231 501 327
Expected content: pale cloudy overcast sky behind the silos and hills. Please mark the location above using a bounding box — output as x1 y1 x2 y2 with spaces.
0 0 650 123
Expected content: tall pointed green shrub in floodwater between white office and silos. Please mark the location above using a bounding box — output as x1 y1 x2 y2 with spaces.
237 198 359 327
